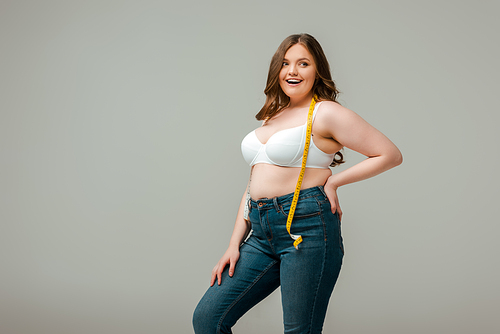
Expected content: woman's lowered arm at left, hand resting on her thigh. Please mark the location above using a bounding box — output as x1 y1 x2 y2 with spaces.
210 181 251 286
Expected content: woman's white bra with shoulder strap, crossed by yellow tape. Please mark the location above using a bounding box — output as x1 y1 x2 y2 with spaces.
241 102 335 168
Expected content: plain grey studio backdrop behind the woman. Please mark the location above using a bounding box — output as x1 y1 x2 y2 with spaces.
0 0 500 334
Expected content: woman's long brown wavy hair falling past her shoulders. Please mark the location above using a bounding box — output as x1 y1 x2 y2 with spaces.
255 34 344 167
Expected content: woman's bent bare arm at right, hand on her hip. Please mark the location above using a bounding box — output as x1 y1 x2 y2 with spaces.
321 102 403 216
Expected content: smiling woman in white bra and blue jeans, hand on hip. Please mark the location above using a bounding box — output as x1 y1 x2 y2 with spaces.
193 34 402 334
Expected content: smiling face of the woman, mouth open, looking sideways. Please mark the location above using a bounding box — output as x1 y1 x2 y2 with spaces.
279 44 316 99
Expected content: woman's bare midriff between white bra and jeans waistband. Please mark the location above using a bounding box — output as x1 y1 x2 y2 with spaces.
250 163 332 200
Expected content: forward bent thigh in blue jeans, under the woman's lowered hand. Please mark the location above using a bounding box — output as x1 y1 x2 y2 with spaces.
193 244 280 334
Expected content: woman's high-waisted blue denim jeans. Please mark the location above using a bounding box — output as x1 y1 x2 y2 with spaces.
193 186 344 334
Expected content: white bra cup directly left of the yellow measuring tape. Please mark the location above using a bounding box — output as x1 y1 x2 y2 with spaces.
266 126 305 166
